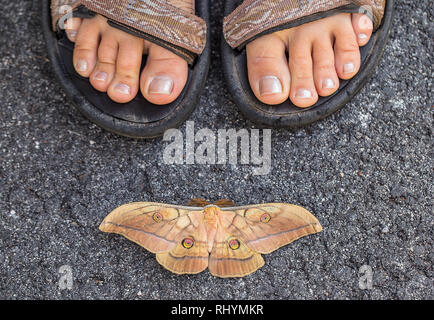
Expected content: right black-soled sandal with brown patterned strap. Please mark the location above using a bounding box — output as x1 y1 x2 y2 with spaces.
222 0 394 128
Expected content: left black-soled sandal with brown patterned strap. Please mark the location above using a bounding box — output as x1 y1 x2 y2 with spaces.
42 0 210 138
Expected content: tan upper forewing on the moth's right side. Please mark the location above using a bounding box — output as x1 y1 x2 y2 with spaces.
221 203 322 253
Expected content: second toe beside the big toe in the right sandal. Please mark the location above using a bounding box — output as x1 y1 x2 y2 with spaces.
289 34 318 108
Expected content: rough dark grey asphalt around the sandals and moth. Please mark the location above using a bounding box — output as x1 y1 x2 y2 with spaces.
0 0 434 300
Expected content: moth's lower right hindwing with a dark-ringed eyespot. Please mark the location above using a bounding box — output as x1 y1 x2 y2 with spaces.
208 212 265 278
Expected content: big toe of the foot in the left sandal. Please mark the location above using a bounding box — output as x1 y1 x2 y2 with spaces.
140 43 188 105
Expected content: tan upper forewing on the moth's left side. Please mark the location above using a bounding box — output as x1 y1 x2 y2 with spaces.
99 202 203 253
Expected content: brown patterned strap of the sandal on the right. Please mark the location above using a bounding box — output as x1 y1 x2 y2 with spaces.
223 0 386 48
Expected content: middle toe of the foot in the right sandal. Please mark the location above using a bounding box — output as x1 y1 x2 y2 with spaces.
312 38 339 97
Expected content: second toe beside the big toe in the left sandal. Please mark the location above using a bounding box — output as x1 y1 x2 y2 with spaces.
107 30 143 103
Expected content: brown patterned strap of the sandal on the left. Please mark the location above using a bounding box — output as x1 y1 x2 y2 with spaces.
51 0 207 63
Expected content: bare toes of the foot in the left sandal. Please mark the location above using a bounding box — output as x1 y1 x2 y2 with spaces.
66 0 194 105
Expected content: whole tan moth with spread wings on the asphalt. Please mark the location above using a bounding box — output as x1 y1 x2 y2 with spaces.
99 199 322 278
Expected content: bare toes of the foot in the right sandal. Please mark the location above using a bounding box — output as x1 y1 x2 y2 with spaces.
247 13 373 108
